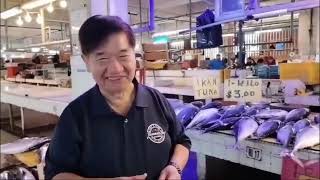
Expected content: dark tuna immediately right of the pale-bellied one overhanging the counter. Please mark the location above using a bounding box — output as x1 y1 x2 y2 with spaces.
256 119 281 139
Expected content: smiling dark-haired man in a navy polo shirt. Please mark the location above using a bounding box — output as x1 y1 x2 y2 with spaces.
45 15 191 179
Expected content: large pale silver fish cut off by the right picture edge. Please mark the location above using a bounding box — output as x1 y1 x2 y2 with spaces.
291 125 320 154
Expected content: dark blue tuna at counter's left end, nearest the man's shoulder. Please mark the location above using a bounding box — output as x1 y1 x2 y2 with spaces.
177 104 199 126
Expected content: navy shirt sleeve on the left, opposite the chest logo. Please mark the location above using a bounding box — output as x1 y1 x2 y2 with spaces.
44 106 81 179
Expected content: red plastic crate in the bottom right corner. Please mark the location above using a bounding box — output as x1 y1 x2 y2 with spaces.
281 157 320 180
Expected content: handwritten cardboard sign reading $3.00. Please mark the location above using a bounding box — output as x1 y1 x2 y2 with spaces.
224 79 262 102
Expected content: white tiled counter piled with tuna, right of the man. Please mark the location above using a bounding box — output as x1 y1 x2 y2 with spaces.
169 99 320 175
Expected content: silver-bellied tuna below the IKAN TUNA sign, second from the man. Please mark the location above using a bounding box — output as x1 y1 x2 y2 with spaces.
186 108 220 129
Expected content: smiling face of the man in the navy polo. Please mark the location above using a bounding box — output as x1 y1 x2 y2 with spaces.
84 33 136 93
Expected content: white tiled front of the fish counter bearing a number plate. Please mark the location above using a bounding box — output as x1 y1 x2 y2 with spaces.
186 130 320 174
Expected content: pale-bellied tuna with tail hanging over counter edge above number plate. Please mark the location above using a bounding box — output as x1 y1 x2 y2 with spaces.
233 117 258 149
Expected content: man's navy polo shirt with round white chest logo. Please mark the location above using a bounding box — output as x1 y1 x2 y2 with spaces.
44 80 191 179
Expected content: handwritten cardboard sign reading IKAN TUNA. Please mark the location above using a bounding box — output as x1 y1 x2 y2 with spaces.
193 76 221 99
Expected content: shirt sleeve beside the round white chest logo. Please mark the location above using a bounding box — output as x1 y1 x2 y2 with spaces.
160 94 191 150
